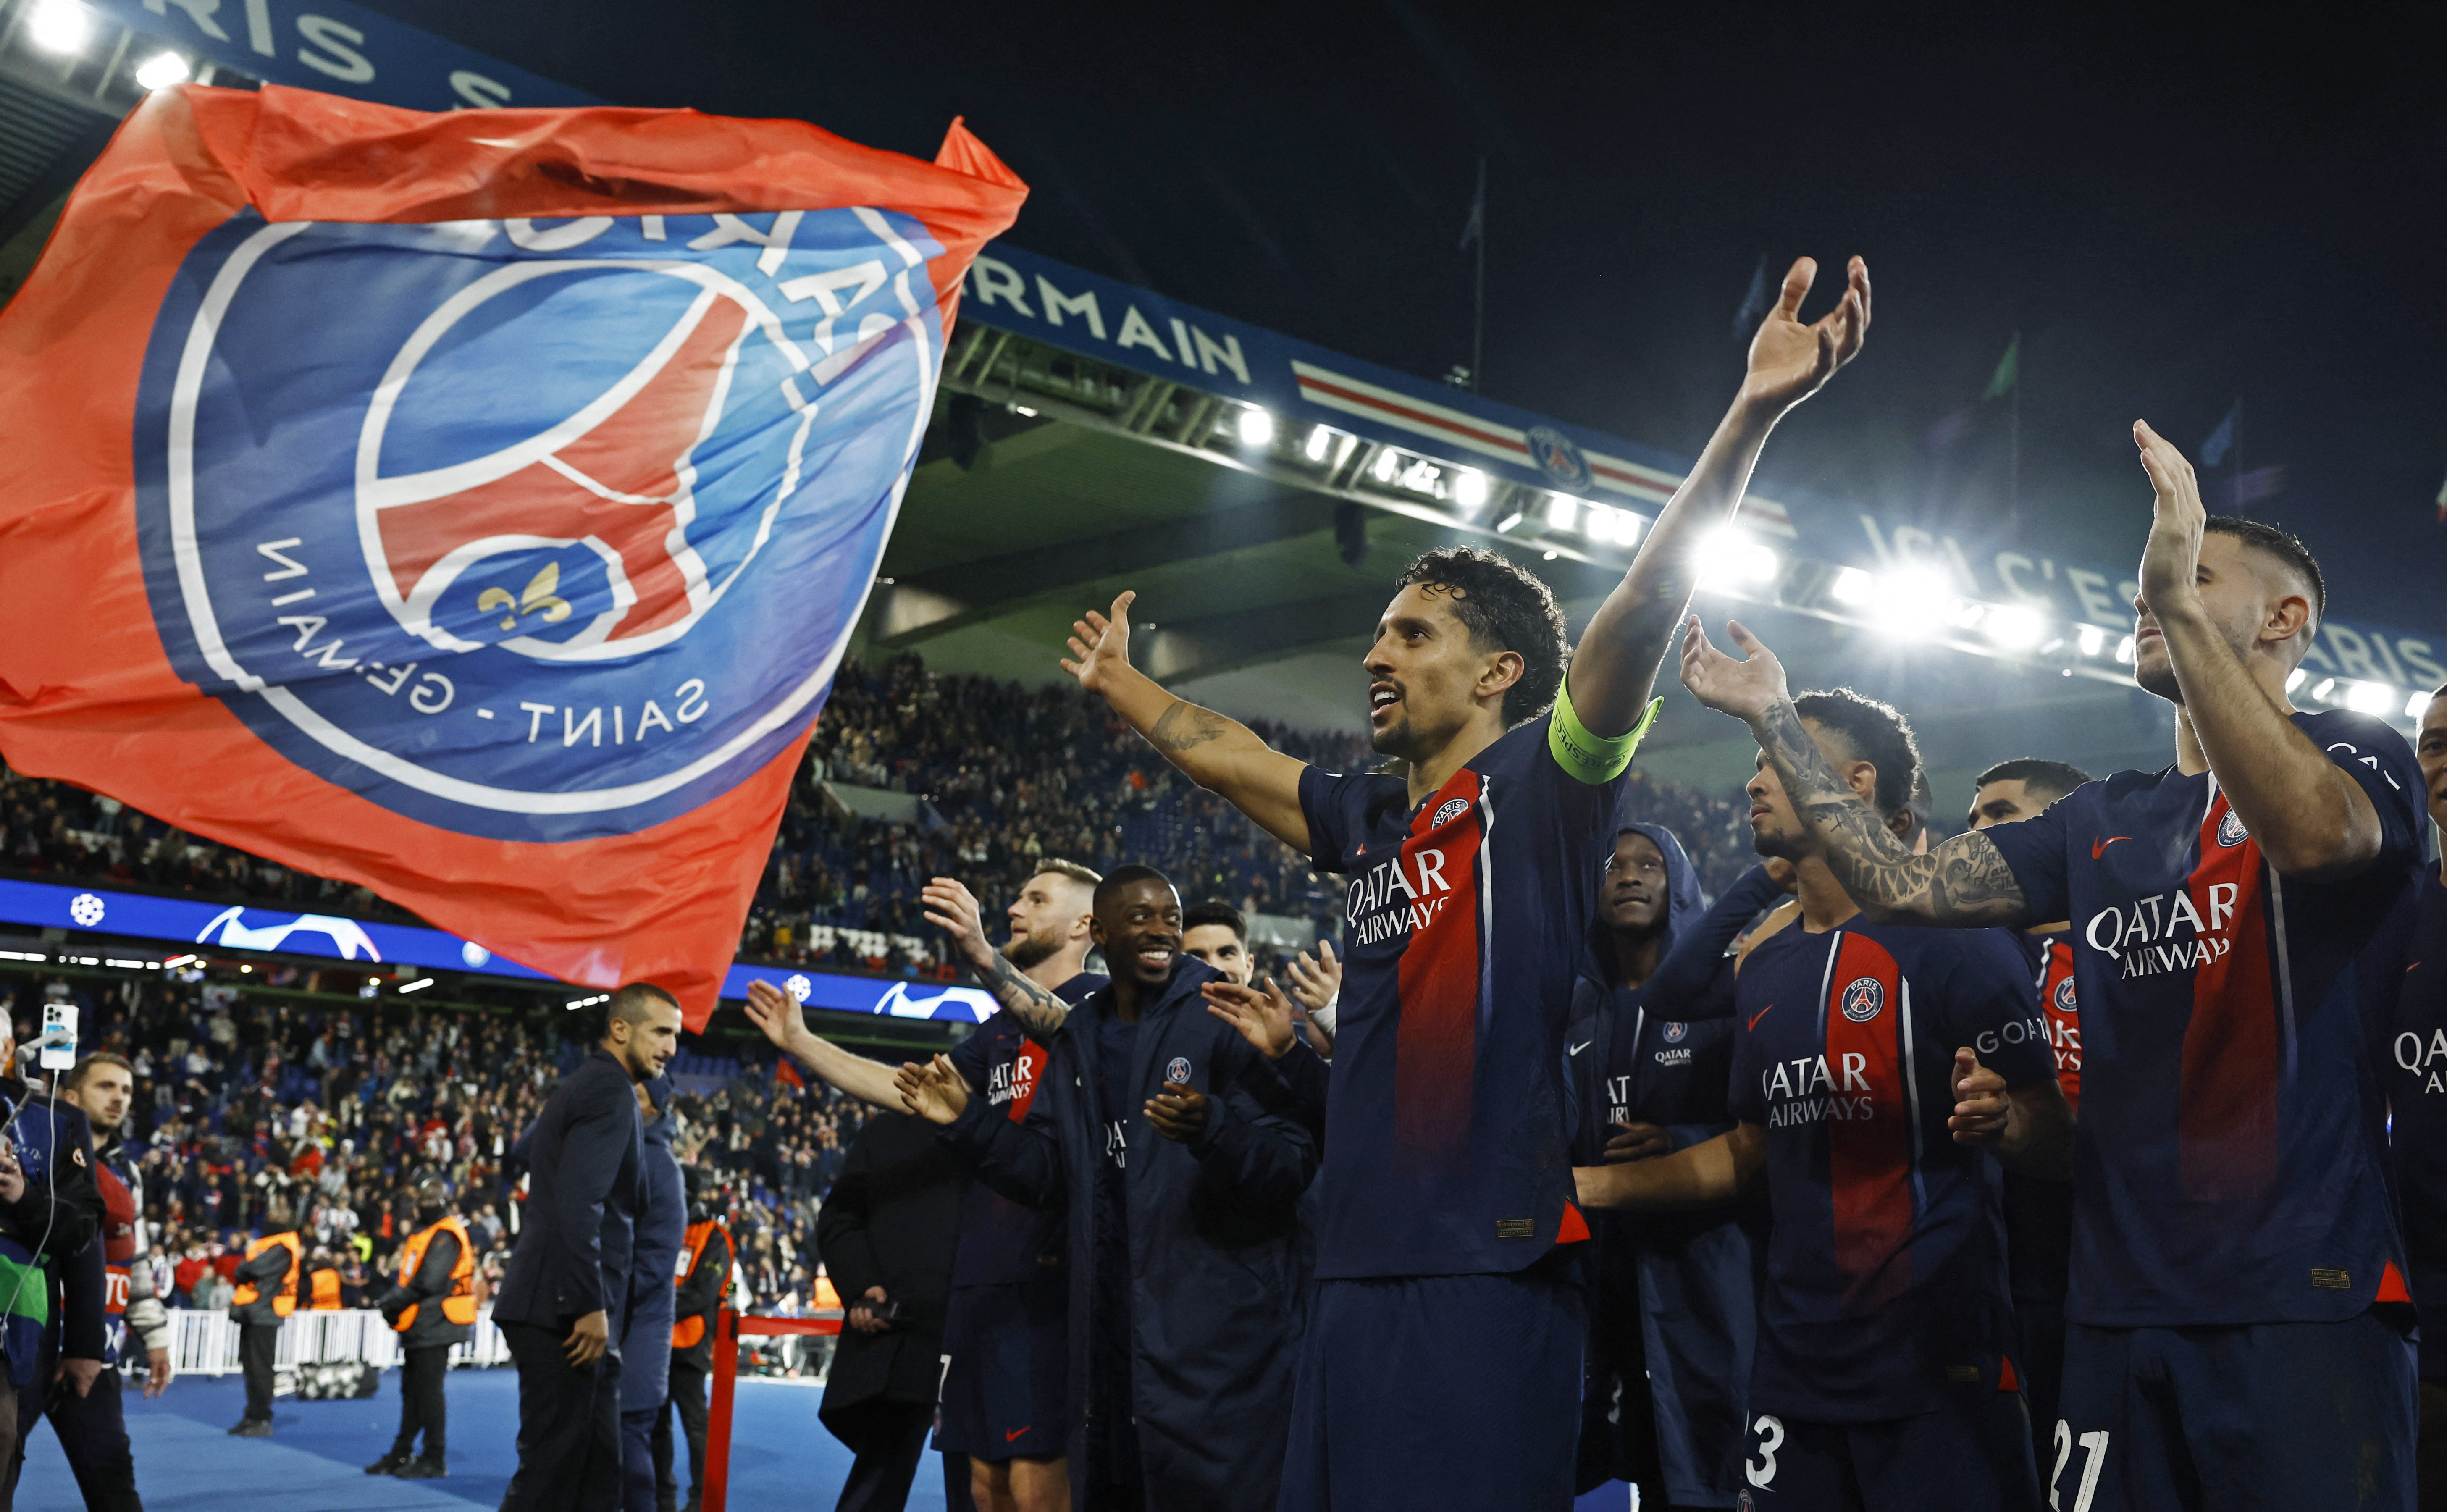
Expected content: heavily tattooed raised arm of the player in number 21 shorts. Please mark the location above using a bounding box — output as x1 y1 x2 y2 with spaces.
1683 617 2033 925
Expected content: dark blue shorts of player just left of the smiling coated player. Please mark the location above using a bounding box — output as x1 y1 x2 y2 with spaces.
935 1272 1069 1461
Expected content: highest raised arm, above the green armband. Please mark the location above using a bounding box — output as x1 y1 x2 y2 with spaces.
1568 257 1869 736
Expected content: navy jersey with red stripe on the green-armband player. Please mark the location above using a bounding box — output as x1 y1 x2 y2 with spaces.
1300 717 1623 1280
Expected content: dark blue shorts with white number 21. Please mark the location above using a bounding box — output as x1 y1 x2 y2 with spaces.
2041 1311 2420 1512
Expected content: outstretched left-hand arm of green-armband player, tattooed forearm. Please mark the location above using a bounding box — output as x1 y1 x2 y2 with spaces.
1062 592 1311 851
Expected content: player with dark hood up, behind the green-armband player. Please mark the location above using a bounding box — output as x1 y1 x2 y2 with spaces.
1564 824 1757 1507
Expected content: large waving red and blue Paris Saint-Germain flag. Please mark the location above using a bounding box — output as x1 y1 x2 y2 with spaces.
0 86 1025 1023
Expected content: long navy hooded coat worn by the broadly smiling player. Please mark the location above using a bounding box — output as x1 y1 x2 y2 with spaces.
942 957 1316 1512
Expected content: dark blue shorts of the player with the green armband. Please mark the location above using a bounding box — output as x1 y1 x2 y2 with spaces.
1282 1265 1586 1512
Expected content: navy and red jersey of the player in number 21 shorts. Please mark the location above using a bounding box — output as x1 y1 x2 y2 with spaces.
1982 709 2423 1328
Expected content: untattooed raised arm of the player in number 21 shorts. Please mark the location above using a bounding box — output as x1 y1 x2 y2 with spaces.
2134 421 2386 878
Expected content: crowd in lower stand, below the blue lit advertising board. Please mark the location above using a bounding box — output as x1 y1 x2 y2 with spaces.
0 964 864 1311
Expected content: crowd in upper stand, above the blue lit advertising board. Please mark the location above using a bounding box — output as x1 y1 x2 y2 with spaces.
0 656 1752 976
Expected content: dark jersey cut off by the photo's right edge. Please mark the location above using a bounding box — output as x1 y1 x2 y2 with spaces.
2388 871 2447 1380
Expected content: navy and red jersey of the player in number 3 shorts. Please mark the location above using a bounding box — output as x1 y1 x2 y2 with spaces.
1728 920 2056 1424
